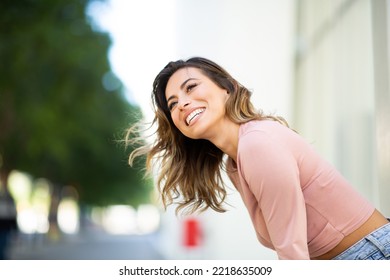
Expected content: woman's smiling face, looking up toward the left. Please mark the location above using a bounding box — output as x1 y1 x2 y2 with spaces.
165 67 229 140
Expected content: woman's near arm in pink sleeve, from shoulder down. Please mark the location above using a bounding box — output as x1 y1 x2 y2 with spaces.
238 131 310 259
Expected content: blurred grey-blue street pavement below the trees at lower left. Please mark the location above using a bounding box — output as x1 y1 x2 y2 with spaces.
8 228 163 260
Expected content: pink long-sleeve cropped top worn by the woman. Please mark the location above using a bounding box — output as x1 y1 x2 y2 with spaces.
227 120 375 259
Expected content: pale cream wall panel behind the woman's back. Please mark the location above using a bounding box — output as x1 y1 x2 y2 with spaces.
294 0 387 208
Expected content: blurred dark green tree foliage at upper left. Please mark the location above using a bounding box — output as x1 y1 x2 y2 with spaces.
0 0 152 206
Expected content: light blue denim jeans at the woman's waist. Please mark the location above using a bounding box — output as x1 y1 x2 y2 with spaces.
333 219 390 260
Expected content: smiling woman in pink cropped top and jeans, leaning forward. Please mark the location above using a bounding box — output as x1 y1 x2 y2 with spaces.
126 57 390 259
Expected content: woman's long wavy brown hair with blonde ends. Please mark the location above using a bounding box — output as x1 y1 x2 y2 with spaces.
126 57 288 213
